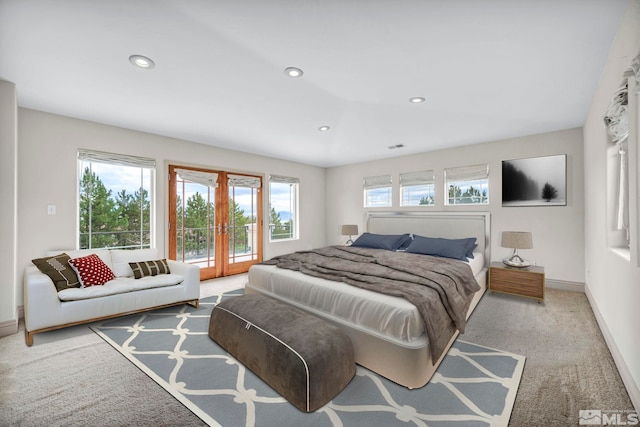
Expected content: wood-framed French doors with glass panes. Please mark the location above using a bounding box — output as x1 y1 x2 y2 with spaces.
169 165 262 280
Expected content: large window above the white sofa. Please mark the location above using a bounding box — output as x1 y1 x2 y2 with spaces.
78 150 155 249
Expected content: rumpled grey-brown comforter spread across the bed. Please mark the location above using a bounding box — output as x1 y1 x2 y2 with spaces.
263 246 480 362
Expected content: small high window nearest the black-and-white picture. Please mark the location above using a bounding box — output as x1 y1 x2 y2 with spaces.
444 165 489 205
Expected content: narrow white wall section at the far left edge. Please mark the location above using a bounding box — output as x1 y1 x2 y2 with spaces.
0 80 18 337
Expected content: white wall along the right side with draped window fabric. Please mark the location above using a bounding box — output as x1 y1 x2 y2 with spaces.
583 0 640 409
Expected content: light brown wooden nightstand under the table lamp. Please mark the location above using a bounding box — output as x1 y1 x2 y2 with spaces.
489 262 544 302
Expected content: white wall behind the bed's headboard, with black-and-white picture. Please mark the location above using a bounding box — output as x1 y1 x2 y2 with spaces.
327 129 584 285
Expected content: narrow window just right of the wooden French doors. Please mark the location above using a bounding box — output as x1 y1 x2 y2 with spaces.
269 175 300 241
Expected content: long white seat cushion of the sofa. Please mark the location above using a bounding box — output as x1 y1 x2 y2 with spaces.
58 274 184 301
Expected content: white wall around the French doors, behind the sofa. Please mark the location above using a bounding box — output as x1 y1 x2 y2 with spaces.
13 108 325 309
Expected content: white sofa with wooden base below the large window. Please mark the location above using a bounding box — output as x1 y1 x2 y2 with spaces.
24 249 200 346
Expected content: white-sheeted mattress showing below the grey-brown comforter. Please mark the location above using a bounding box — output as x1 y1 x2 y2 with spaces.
246 252 485 343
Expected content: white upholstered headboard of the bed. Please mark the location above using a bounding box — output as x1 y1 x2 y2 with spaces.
365 211 491 265
